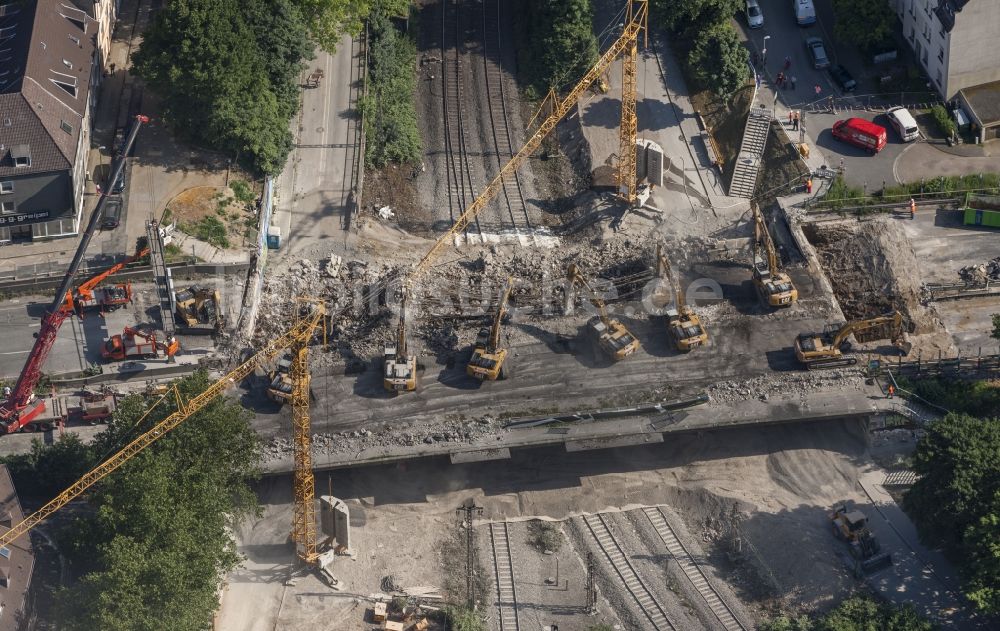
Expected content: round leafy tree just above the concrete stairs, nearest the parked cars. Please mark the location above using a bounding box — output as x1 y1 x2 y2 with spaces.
688 22 749 96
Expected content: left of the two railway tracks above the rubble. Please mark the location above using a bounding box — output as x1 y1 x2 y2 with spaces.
441 0 482 236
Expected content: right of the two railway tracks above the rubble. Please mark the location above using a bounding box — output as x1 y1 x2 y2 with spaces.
483 0 531 239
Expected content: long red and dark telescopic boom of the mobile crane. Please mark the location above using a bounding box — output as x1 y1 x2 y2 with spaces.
0 115 149 434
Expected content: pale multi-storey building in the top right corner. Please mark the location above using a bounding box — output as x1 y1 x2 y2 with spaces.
891 0 1000 100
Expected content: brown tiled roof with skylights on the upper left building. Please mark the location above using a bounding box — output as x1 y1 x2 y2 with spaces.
0 0 97 176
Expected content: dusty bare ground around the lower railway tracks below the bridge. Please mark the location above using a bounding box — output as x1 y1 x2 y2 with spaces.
219 422 900 631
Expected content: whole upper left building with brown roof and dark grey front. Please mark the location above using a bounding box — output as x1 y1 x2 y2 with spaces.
0 0 101 243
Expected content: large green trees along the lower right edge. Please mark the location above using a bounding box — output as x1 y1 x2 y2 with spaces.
903 412 1000 614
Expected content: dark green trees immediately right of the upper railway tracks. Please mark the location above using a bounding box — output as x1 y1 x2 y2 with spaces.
514 0 598 94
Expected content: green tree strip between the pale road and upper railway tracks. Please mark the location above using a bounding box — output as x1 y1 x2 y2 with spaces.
359 0 422 168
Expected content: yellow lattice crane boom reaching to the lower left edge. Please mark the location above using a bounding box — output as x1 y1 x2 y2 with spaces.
0 304 326 547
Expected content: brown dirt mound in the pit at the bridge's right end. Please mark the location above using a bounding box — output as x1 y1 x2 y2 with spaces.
802 217 940 341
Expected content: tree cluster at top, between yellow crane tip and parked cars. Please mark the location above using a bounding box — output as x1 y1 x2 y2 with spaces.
650 0 750 97
